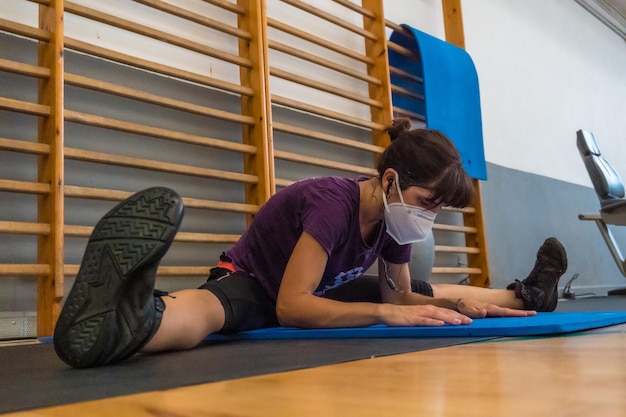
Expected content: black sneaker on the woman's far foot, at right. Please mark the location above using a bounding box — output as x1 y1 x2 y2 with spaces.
506 237 567 311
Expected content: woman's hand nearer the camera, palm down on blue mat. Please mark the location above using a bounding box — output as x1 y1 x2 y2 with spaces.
381 304 472 327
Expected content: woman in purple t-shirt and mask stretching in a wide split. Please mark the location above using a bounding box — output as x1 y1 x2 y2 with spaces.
54 120 567 368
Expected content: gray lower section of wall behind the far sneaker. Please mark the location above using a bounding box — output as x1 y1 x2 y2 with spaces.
481 161 626 295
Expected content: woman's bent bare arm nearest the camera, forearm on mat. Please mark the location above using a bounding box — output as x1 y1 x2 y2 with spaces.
276 232 471 328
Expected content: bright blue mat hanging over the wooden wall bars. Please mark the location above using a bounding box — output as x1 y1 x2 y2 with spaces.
389 25 487 180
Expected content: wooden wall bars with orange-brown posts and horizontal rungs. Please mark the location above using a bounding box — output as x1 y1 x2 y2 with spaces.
0 0 489 336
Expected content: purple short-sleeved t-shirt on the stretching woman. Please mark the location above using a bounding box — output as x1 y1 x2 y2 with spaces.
227 177 411 299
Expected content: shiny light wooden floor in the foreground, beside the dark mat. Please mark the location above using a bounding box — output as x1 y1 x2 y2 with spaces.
7 324 626 417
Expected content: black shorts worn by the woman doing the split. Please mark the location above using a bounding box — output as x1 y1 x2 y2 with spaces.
199 267 433 333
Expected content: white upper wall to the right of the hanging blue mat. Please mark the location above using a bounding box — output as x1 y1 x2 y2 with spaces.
465 0 626 185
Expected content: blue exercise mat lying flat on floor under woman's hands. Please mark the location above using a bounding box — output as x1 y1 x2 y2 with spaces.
206 311 626 340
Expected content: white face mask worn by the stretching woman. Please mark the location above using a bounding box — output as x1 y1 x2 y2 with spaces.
383 172 437 245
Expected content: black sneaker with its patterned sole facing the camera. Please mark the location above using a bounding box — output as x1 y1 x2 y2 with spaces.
54 187 183 368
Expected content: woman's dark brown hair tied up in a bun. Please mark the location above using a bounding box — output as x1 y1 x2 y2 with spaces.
377 118 474 208
